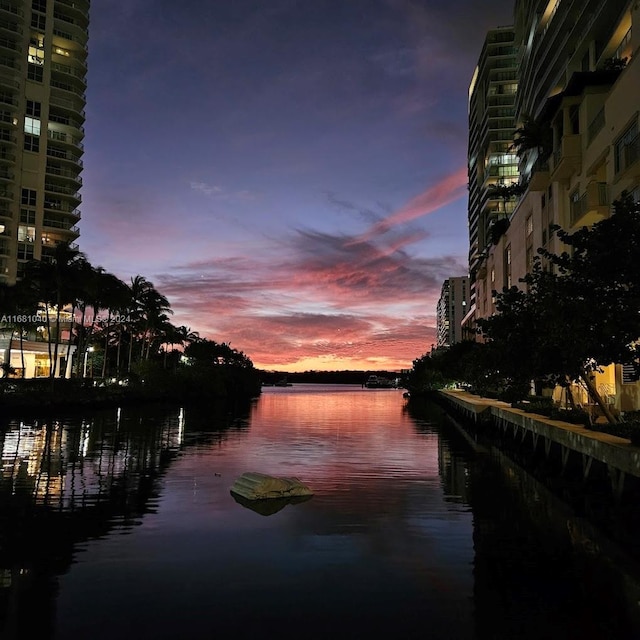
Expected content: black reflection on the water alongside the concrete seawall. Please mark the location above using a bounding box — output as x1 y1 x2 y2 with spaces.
410 405 640 638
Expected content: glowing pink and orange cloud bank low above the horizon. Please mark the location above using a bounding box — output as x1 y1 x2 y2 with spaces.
155 231 456 371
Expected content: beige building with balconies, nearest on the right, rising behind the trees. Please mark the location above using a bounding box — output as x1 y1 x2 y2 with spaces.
470 0 640 411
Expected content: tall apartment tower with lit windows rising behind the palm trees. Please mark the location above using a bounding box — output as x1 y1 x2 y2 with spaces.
0 0 89 284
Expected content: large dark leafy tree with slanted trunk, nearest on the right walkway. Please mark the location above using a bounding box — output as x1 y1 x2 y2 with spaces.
480 195 640 422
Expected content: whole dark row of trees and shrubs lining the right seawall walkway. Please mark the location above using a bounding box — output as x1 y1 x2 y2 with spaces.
407 193 640 444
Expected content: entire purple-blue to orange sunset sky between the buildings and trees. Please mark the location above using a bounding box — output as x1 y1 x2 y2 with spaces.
79 0 513 371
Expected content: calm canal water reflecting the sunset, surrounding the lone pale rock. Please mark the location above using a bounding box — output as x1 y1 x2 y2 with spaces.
0 385 640 640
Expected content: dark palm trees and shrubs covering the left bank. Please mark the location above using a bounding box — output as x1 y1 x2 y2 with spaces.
0 244 261 414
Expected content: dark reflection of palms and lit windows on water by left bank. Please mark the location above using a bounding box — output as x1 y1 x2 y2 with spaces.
0 407 248 638
